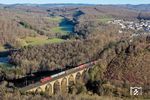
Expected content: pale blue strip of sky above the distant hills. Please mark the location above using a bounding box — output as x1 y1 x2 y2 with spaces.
0 0 150 4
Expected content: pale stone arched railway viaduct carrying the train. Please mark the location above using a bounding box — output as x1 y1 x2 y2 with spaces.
22 67 93 95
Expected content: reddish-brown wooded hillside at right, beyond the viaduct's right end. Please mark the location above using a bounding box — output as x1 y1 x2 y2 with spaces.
83 36 150 99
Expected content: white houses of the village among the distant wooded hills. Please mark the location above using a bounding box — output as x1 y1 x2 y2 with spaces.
109 20 150 32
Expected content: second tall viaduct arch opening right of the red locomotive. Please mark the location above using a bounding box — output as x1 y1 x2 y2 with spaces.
61 77 68 94
